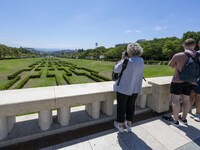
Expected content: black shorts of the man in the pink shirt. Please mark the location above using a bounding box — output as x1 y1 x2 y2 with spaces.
170 82 194 95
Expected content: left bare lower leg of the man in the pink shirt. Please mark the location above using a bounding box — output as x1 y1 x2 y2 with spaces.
171 94 180 121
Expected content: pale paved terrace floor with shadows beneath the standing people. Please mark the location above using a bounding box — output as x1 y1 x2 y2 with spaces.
41 110 200 150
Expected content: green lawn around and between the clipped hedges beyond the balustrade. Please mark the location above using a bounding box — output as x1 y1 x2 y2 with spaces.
0 58 174 88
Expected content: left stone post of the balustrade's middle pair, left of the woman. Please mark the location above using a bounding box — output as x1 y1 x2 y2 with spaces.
38 110 52 130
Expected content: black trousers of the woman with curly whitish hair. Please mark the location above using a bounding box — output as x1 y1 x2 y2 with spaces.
117 92 138 123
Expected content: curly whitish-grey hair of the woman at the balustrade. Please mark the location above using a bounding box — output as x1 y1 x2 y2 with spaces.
127 43 143 56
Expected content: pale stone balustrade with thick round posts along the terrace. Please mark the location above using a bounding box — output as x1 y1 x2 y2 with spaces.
0 77 171 140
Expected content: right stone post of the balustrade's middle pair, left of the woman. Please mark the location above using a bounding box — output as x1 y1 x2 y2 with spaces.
58 106 70 126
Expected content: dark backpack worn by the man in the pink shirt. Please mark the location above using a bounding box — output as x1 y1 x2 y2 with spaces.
179 52 200 83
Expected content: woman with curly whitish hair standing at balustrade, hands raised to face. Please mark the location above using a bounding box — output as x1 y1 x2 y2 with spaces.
114 43 144 133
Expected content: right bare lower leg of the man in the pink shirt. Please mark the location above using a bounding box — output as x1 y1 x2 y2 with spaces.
182 95 191 120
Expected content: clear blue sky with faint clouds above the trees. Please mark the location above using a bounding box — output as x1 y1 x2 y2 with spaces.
0 0 200 49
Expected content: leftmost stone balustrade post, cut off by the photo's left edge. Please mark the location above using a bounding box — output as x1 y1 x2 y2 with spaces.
0 116 8 140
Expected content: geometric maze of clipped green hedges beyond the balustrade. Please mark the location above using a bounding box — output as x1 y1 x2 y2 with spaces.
0 58 111 90
